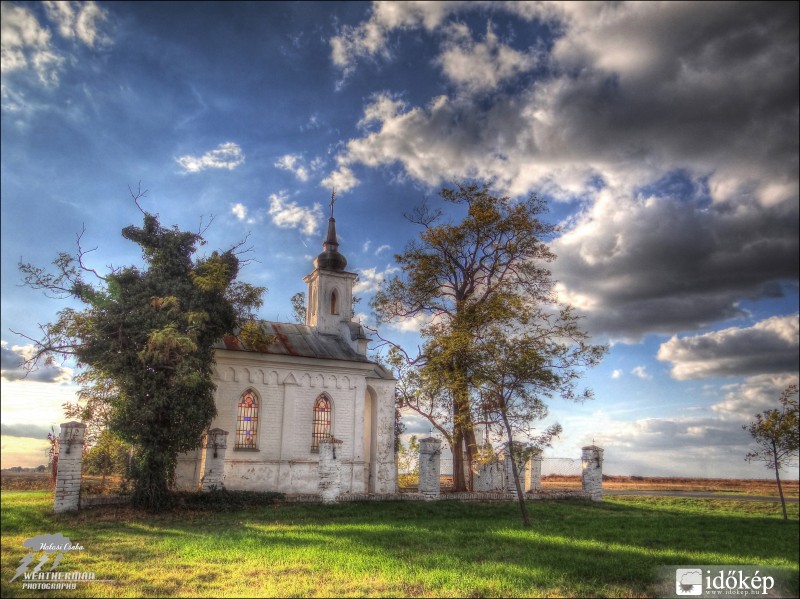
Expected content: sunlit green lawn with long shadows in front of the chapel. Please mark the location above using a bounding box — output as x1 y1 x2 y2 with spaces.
2 491 800 597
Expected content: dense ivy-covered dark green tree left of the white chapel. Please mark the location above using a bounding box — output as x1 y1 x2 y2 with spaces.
20 194 269 511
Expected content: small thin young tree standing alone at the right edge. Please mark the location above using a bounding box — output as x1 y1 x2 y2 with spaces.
742 385 800 521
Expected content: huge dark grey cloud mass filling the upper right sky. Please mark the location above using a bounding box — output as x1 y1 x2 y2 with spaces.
328 3 800 340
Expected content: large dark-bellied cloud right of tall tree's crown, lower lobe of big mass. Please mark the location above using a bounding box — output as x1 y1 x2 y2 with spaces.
553 189 800 339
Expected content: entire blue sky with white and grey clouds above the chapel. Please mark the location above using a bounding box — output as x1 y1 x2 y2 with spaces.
0 2 799 478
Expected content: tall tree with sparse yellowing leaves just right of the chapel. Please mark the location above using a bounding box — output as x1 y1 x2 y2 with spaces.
373 183 602 490
